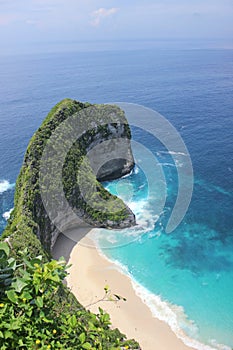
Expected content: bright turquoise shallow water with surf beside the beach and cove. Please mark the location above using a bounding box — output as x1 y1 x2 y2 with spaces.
98 132 233 349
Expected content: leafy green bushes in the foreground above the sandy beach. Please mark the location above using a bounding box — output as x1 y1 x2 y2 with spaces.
0 242 139 350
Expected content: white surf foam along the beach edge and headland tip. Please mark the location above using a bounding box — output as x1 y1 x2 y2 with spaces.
99 172 230 350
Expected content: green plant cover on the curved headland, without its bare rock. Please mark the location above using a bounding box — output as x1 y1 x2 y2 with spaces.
3 99 134 252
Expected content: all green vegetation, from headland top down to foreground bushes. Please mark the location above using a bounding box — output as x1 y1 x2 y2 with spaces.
0 99 139 350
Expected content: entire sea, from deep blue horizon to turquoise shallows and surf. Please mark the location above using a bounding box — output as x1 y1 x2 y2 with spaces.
0 48 233 349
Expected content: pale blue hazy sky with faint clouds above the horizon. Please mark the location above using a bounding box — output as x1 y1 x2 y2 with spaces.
0 0 233 53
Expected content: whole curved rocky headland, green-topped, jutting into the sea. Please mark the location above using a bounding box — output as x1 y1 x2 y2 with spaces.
3 99 135 250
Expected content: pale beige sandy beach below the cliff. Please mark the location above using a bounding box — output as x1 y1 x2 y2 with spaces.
53 230 195 350
